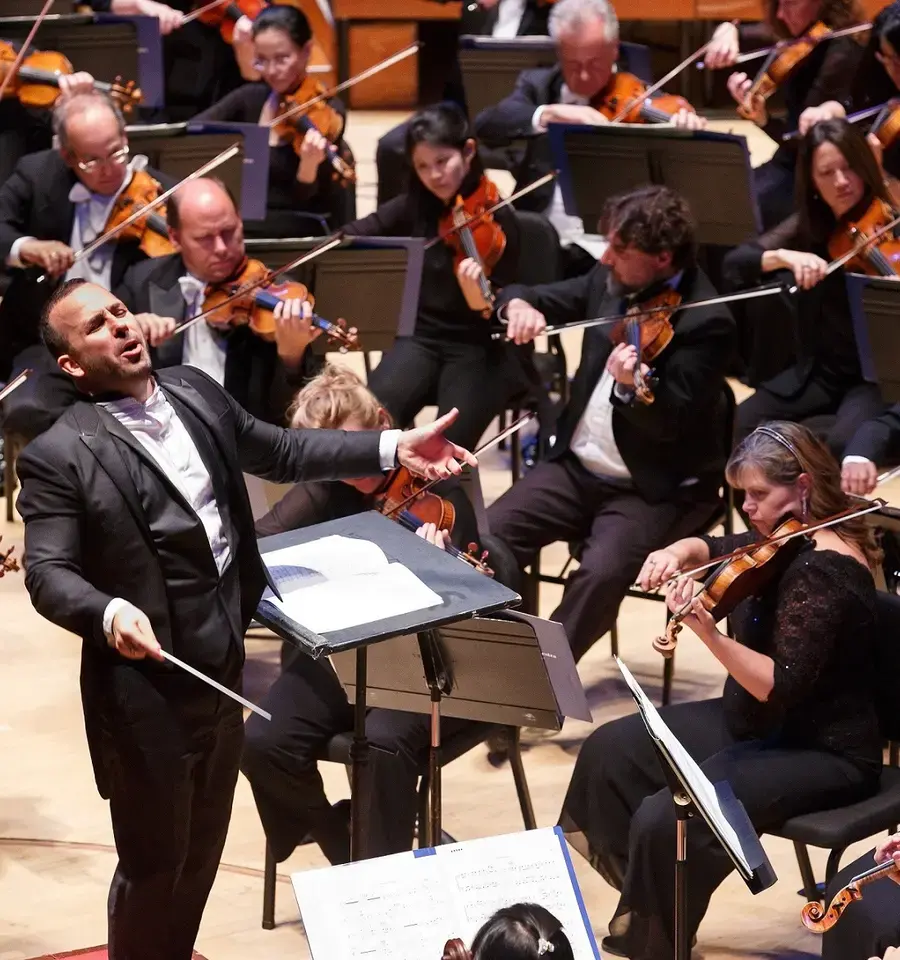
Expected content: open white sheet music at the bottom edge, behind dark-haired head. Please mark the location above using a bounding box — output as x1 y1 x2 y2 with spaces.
291 827 600 960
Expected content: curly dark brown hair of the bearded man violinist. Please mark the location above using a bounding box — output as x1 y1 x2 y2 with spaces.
599 186 696 270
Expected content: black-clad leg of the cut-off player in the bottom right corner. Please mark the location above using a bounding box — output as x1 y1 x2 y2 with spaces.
822 849 900 960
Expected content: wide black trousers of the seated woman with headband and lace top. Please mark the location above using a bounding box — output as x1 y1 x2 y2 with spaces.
560 699 878 960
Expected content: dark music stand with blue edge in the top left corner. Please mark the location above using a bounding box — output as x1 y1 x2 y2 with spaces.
0 11 165 107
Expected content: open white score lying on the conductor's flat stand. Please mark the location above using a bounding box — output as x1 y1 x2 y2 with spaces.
263 536 443 633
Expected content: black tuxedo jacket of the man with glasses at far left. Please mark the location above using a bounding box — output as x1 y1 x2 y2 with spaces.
0 150 159 380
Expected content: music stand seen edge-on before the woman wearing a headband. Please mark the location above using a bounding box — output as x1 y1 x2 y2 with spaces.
615 657 778 960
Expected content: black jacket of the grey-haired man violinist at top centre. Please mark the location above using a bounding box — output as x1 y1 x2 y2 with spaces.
475 66 563 213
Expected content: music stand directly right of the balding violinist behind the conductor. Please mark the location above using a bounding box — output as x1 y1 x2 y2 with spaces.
246 237 424 354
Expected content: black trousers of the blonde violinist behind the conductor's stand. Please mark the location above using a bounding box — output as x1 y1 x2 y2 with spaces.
241 651 488 863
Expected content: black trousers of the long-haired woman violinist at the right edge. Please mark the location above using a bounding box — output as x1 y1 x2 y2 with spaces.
734 373 884 461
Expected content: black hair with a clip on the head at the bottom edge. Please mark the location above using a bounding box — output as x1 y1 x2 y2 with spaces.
471 903 574 960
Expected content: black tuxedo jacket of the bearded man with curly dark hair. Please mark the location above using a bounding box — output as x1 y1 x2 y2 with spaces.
500 264 735 502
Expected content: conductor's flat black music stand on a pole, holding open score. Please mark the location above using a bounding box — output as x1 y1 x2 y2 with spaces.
256 512 521 860
